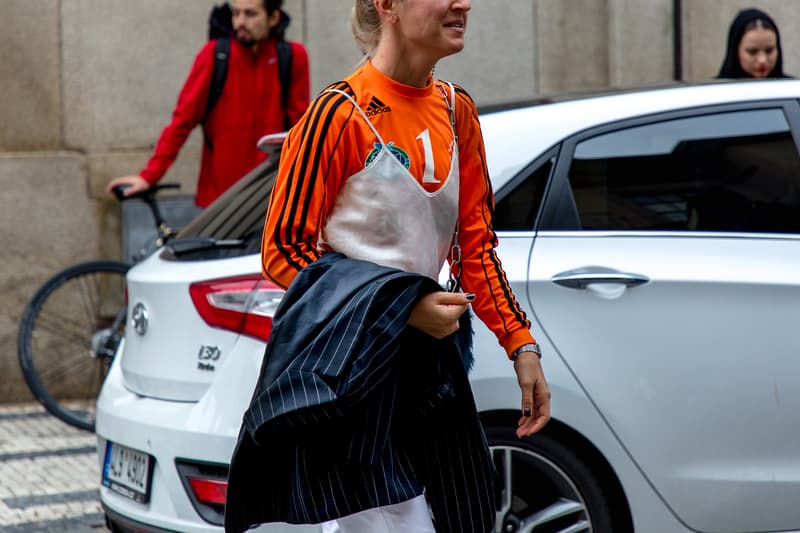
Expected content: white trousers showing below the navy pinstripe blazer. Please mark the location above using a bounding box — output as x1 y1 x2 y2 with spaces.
322 495 436 533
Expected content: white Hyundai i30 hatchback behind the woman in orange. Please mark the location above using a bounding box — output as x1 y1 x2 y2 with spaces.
97 80 800 533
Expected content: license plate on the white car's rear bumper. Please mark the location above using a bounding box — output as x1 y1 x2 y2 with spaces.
103 441 155 503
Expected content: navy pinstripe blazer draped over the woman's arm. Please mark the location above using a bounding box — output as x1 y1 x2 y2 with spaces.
225 253 495 533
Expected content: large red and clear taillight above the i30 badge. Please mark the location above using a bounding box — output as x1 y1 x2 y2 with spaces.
189 274 283 341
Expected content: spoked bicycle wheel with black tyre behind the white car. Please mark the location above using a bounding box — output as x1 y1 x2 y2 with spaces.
17 261 130 431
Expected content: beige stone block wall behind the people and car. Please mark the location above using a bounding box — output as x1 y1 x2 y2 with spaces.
0 0 800 402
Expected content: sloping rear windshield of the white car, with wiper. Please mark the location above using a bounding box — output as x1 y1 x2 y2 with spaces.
161 158 277 261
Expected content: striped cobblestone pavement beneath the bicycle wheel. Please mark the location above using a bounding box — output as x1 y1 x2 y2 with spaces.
0 403 108 533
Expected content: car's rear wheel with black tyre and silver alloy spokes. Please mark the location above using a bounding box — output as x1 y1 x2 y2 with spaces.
486 427 614 533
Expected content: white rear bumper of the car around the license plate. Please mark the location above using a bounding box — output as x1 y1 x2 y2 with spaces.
96 350 321 533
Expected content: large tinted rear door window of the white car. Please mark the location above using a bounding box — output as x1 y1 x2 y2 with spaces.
569 108 800 233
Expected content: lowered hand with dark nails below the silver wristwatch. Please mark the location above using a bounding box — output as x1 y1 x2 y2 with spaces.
514 352 550 438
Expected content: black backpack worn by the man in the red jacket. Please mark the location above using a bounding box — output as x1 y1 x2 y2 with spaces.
201 3 292 147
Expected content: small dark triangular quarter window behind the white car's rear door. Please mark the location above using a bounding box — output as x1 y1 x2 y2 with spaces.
492 158 554 227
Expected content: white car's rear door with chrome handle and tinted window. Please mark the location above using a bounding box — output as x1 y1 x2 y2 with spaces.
529 101 800 532
